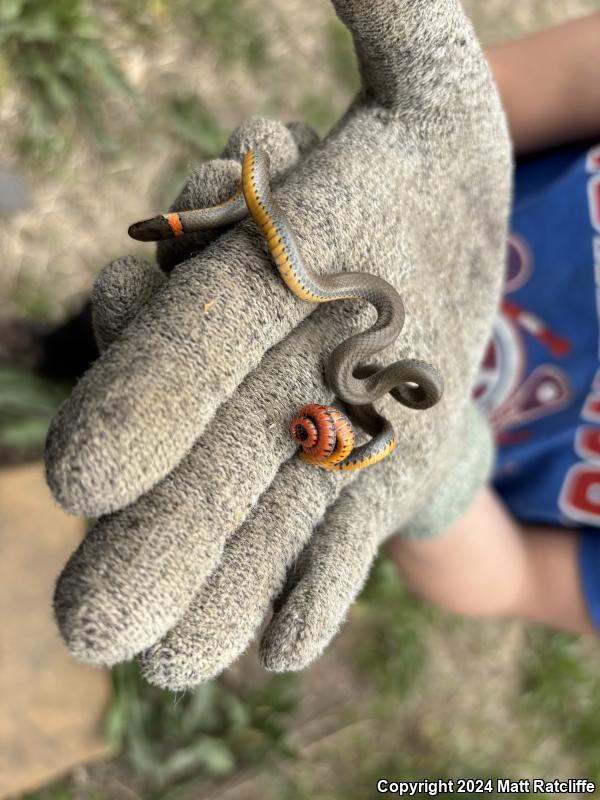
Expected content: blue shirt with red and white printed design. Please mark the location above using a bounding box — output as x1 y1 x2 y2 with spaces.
475 136 600 630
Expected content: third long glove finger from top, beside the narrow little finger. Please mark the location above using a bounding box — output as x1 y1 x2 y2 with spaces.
140 459 347 690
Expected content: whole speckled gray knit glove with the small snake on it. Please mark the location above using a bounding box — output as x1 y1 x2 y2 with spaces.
47 0 510 689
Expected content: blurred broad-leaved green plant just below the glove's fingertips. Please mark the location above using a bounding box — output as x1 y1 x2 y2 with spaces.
106 664 298 797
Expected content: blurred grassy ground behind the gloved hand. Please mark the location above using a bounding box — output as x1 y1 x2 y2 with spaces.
0 0 600 800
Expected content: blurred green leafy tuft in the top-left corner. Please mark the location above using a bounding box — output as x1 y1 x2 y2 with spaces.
0 0 136 162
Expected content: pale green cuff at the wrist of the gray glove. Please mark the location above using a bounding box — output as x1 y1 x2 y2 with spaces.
399 400 495 539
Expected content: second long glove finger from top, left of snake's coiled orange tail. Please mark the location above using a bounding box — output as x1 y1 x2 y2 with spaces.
54 304 368 664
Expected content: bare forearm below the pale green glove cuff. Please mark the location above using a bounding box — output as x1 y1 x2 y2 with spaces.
387 488 598 635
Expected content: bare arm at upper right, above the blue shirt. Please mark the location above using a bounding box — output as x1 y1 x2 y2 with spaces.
486 13 600 153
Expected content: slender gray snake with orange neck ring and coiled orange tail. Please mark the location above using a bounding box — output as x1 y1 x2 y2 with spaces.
128 148 443 472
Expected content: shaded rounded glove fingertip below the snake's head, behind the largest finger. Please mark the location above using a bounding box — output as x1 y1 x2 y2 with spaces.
92 256 166 352
